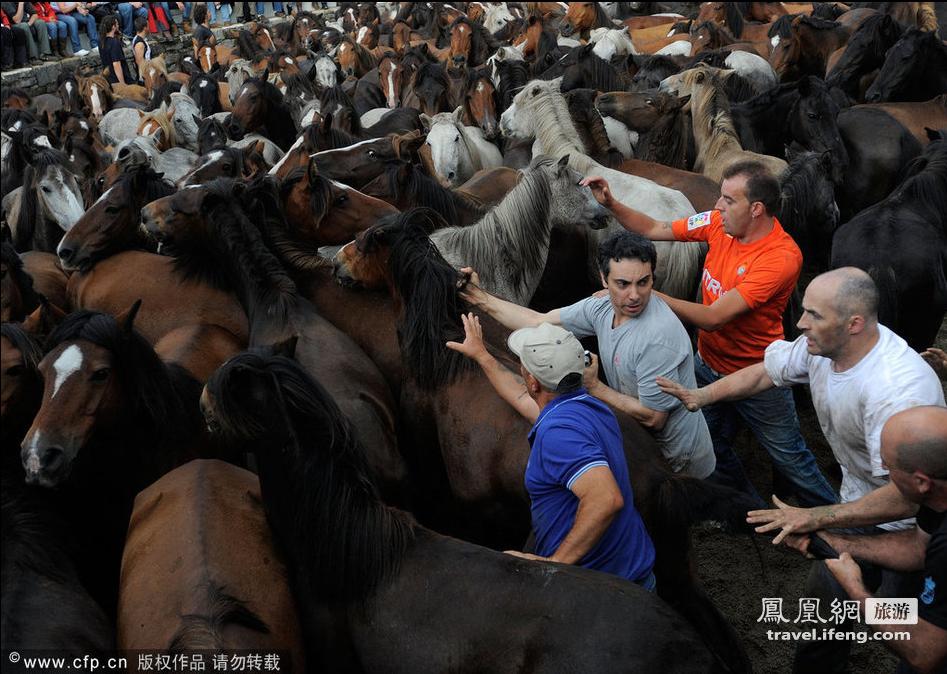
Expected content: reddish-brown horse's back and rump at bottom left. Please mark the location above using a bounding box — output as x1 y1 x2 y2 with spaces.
117 460 305 672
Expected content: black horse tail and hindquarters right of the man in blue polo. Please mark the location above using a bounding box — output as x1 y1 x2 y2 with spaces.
649 475 755 673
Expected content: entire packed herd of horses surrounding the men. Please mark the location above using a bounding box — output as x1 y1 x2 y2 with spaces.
0 2 947 672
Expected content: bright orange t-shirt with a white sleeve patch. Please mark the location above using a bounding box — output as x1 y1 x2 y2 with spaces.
673 211 802 374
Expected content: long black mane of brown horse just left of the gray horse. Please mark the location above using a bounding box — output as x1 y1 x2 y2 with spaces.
366 208 473 390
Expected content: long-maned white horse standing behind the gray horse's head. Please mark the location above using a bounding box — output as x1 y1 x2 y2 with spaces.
500 78 702 300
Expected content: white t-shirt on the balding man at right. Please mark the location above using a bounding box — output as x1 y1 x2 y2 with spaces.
763 325 945 529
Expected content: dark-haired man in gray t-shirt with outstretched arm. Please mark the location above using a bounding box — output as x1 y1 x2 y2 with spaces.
463 230 716 479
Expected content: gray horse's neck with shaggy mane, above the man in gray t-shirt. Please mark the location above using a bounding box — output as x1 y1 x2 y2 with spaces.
431 168 552 304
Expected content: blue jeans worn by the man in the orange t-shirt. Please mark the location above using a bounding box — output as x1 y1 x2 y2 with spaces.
694 354 838 507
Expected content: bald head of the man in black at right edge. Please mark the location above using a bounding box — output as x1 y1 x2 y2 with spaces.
881 406 947 480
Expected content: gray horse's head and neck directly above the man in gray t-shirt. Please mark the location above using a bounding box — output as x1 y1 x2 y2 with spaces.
431 155 612 306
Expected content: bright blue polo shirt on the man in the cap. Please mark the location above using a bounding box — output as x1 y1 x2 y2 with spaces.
526 389 654 581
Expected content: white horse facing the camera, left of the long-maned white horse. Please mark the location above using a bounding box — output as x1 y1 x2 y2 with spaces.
421 107 503 187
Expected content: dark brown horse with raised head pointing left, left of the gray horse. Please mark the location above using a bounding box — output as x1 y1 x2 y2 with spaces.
142 180 406 502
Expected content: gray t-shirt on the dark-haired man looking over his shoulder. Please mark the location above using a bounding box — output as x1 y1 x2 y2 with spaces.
560 295 717 479
